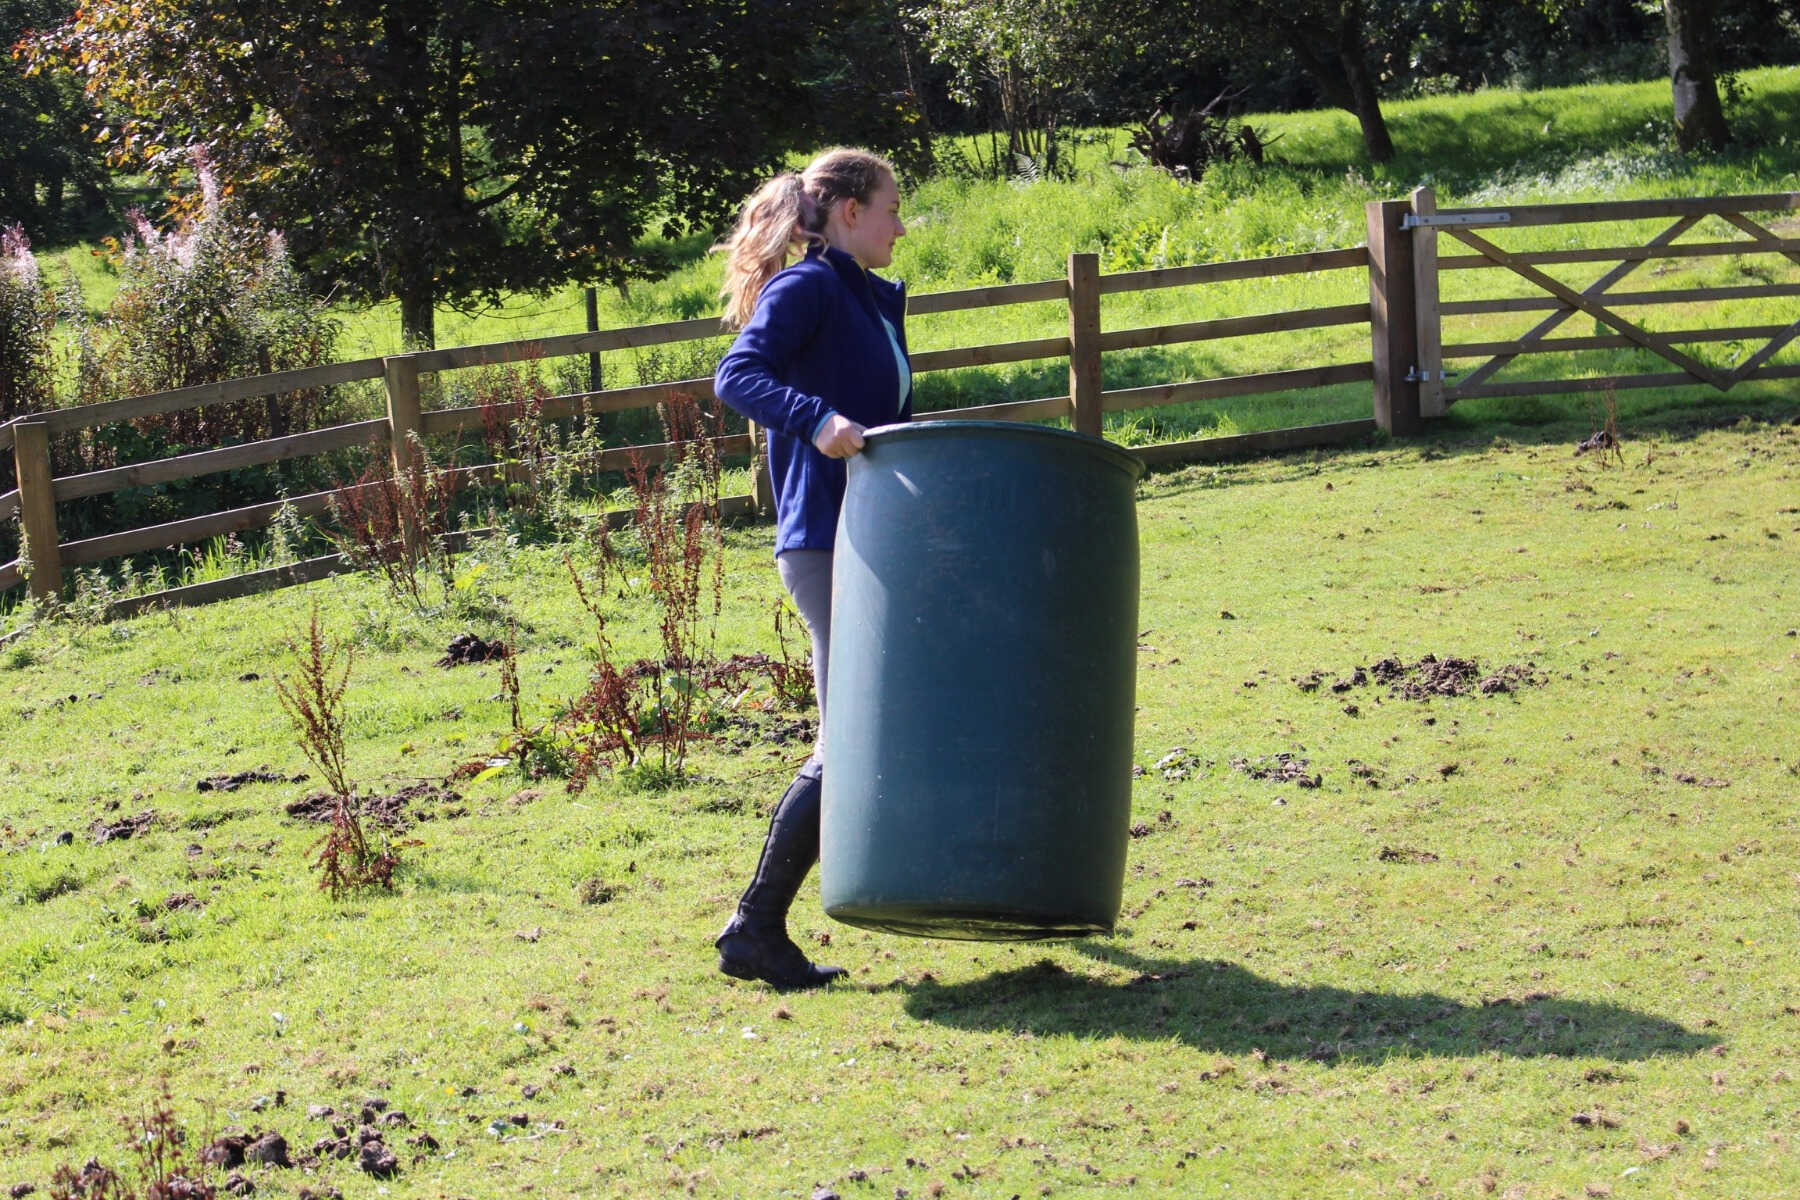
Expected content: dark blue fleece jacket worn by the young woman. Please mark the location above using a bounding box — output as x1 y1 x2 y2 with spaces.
713 246 913 554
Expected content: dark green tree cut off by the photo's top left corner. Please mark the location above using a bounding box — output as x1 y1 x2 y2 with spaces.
0 0 106 237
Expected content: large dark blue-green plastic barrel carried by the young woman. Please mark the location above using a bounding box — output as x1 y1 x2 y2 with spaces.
819 421 1143 941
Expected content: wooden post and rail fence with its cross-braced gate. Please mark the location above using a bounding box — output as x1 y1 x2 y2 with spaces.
0 189 1800 613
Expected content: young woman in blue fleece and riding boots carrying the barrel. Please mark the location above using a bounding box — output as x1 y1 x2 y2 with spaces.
713 148 913 988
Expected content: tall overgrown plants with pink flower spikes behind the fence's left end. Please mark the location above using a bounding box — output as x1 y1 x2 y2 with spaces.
0 157 340 564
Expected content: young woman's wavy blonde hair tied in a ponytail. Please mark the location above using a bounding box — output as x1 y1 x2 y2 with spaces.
713 146 895 329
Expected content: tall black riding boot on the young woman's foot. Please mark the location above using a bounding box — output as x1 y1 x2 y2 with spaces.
715 763 844 991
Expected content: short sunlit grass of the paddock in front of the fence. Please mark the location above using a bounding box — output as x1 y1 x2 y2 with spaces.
0 389 1800 1198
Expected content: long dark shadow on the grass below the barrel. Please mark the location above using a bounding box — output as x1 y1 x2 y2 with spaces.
905 943 1717 1063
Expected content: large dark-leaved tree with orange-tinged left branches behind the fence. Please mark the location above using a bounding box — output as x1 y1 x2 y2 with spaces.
31 0 892 345
